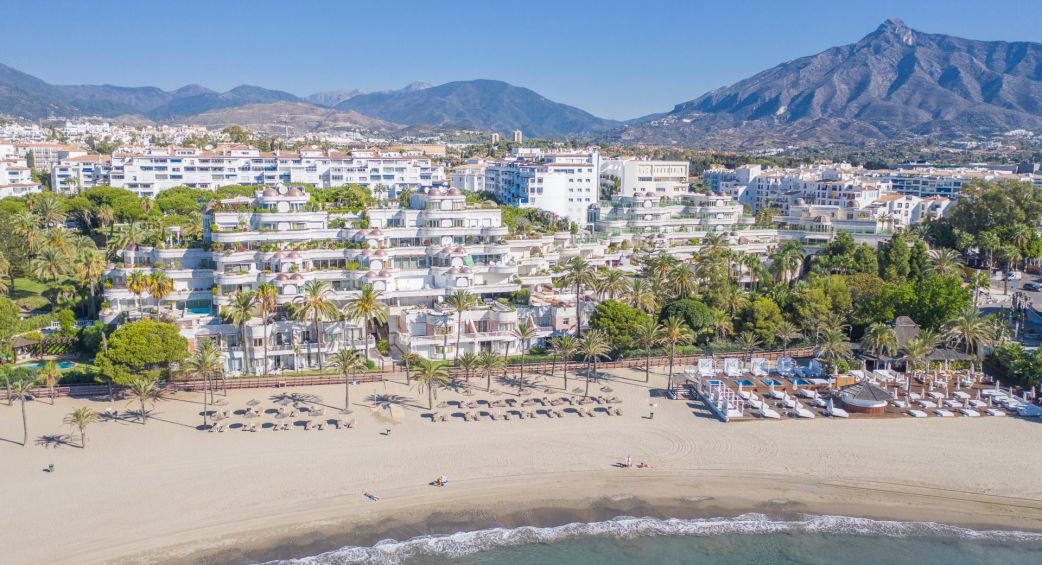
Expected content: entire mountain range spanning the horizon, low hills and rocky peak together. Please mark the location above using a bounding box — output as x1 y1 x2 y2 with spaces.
0 20 1042 145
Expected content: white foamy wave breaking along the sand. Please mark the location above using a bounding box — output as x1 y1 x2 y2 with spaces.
265 514 1042 565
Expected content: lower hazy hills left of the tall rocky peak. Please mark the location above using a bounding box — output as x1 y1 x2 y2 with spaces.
0 65 621 137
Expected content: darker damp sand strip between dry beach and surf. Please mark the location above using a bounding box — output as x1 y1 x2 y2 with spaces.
121 469 1042 564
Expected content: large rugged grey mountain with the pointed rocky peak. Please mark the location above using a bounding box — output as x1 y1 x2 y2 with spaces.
618 20 1042 148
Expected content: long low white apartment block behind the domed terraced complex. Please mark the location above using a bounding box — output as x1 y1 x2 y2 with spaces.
109 144 444 198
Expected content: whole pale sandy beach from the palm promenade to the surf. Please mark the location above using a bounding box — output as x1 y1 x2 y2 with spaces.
0 369 1042 563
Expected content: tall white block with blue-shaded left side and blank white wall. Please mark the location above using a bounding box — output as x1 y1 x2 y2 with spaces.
485 151 600 227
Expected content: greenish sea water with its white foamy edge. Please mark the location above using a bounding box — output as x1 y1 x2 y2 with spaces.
258 514 1042 565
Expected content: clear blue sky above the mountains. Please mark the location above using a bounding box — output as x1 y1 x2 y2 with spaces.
0 0 1042 119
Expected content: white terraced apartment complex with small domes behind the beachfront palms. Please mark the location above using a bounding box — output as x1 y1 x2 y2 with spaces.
102 187 520 372
